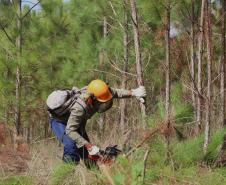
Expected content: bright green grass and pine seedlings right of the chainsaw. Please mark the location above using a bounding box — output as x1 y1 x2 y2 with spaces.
110 129 226 185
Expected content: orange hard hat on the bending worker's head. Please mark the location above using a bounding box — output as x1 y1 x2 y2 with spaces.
87 80 112 102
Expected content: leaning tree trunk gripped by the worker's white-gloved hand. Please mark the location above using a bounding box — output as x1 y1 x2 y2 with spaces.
130 0 146 128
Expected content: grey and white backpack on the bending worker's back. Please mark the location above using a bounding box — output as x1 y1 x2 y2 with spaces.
46 87 88 116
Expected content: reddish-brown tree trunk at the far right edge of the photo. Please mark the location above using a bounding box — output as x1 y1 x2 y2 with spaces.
220 0 226 126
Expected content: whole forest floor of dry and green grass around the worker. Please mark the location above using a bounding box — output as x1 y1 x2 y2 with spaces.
0 131 226 185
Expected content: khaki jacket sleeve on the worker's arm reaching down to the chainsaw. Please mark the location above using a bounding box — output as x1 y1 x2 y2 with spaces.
66 103 88 148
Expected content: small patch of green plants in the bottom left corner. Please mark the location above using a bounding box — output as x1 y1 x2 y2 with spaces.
0 176 33 185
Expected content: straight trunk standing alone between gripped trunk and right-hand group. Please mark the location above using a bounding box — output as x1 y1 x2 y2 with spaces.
165 0 171 160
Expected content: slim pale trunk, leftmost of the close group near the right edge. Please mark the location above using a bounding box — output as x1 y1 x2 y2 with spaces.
190 0 196 120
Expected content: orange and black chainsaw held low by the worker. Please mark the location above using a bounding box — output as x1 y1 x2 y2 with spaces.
89 145 122 165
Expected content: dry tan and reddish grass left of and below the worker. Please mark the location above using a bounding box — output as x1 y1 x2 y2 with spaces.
0 141 112 185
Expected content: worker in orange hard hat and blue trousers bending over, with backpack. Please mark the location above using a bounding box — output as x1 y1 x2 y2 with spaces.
47 79 146 162
